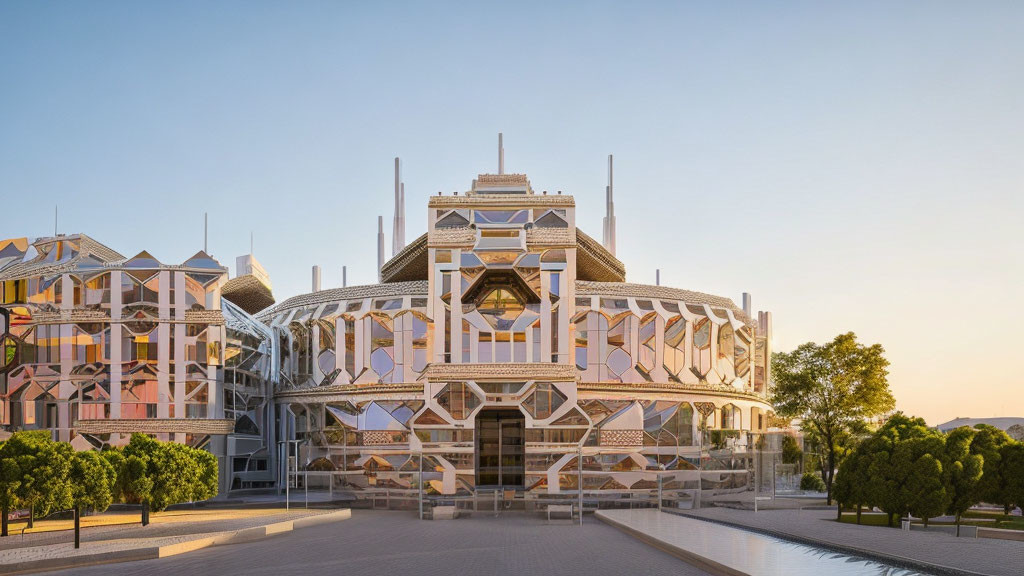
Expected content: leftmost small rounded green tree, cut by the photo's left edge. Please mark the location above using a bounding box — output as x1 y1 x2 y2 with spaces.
3 430 74 528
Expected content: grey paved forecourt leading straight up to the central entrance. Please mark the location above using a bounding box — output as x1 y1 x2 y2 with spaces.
44 510 703 576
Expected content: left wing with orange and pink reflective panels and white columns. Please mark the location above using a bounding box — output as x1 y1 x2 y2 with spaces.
0 235 274 488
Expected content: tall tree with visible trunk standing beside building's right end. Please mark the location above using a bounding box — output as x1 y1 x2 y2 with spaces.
772 332 895 503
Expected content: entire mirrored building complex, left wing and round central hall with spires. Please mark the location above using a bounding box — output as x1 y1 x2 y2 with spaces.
0 145 771 499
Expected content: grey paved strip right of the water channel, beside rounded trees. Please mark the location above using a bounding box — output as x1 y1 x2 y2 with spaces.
688 508 1024 576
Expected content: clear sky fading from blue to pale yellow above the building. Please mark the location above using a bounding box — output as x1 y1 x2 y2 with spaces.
0 0 1024 424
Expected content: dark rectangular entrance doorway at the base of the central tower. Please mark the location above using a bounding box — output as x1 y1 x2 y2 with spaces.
476 410 526 488
